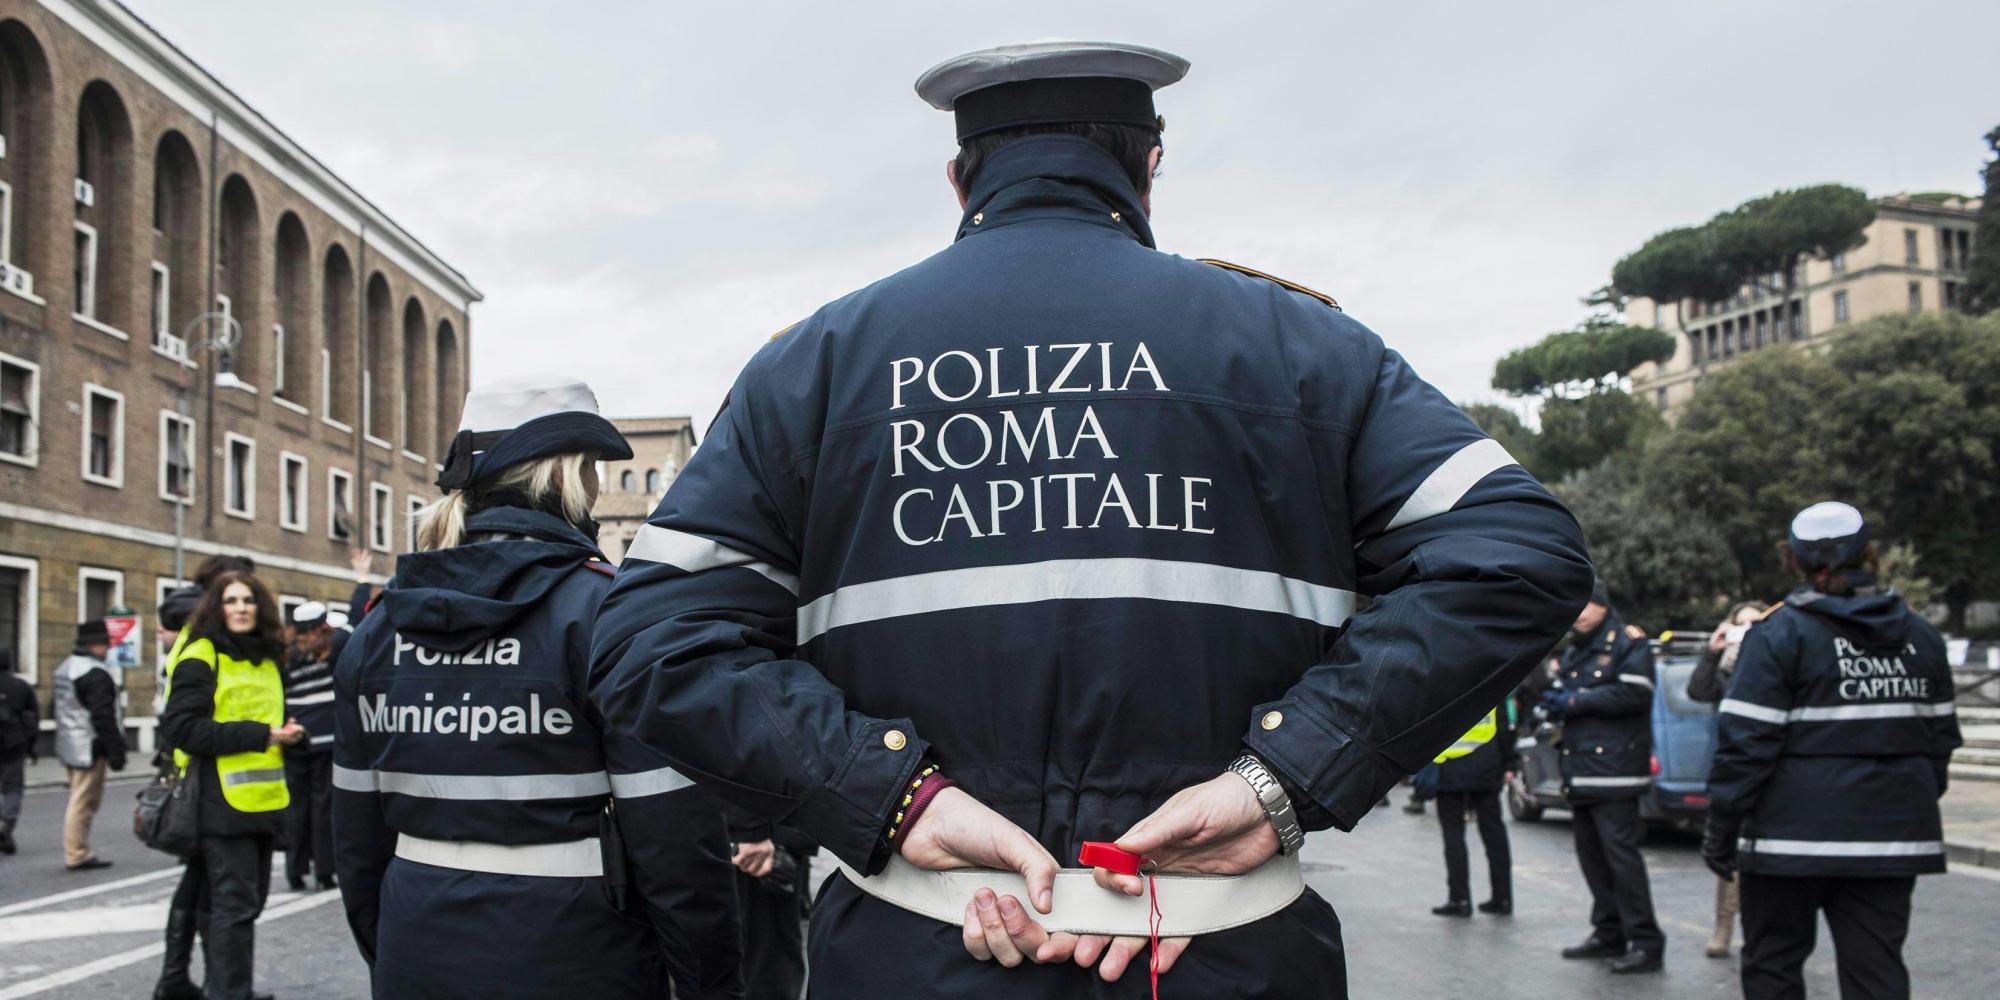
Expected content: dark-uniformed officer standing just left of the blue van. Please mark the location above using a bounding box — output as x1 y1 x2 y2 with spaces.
1542 580 1666 972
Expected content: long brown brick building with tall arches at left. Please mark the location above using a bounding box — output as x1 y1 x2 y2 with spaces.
0 0 480 746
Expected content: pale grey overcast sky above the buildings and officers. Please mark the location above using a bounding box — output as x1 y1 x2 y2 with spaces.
130 0 2000 428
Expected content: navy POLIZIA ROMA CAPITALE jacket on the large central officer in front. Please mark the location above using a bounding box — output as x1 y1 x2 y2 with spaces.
592 136 1590 996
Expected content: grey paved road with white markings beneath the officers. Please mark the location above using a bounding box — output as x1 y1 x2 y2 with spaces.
0 784 2000 1000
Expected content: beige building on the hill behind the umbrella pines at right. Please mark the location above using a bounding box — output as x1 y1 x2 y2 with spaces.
1626 196 1980 414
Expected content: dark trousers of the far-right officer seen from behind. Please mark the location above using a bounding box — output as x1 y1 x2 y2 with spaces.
1742 872 1916 1000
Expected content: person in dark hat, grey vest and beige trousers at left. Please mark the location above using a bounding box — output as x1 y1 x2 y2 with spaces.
50 620 126 872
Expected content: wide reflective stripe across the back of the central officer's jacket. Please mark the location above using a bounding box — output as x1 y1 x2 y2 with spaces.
798 558 1354 642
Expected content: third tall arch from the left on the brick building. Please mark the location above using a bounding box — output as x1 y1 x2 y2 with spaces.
144 130 208 356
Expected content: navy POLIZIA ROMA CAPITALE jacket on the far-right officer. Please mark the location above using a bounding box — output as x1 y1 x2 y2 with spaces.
1708 588 1960 878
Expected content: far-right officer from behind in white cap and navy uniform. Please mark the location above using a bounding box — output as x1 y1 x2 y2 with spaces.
1702 502 1960 1000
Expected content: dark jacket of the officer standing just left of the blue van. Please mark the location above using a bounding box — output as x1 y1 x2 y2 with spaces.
1556 610 1652 802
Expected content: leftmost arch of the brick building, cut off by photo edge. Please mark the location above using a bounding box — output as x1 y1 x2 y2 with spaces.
0 20 62 296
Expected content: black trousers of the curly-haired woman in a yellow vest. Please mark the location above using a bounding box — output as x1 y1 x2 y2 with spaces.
160 836 270 1000
